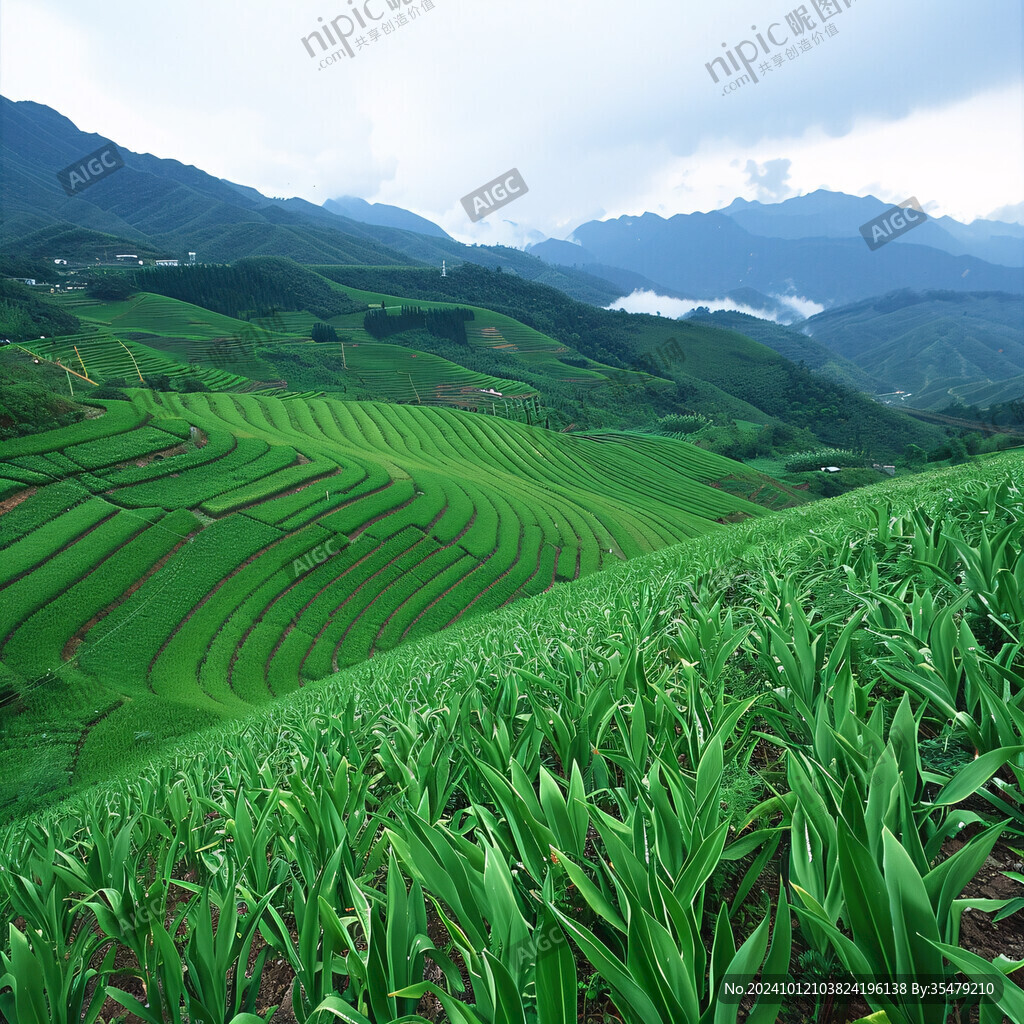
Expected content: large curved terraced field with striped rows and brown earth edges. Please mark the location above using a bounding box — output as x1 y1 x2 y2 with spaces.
0 390 800 805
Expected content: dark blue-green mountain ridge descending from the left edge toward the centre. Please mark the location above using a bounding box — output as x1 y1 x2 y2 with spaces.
0 97 622 305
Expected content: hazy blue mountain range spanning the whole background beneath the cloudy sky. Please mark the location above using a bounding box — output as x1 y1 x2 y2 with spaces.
0 97 1024 408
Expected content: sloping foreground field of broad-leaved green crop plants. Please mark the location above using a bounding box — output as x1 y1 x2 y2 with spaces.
0 452 1024 1024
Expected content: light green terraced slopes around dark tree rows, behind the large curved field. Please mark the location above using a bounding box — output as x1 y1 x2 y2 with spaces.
44 283 670 413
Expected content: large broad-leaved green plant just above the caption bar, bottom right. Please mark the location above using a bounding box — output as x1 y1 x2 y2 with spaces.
791 737 1006 1024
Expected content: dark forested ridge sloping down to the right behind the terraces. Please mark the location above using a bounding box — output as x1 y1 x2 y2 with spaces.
317 265 942 460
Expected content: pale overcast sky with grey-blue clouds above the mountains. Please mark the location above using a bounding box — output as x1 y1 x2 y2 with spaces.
0 0 1024 246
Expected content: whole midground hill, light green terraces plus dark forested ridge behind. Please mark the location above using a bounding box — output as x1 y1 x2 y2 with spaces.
18 259 945 462
